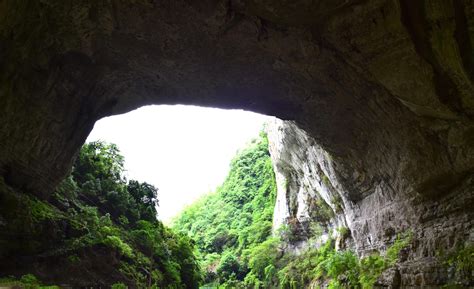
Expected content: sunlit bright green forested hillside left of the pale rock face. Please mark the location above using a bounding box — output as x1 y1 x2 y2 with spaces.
174 133 276 287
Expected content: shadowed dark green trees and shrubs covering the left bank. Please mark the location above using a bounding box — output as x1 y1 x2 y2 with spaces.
0 142 201 289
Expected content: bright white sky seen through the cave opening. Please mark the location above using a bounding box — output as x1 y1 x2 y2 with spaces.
87 105 268 223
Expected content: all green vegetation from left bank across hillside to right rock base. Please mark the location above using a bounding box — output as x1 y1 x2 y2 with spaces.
0 133 414 289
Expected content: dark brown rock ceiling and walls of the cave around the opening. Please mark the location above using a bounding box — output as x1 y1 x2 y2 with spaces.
0 0 474 286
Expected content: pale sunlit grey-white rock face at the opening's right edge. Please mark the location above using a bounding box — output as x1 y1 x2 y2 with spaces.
266 119 348 241
